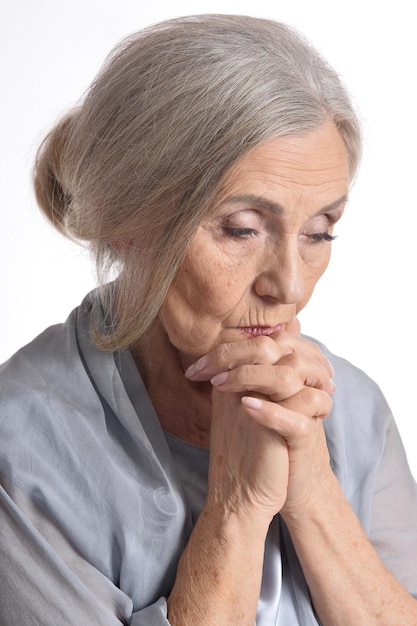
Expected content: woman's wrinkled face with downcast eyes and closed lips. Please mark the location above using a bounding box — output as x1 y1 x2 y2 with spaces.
160 124 349 365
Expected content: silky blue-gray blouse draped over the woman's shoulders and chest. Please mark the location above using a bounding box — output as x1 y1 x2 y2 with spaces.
0 293 417 626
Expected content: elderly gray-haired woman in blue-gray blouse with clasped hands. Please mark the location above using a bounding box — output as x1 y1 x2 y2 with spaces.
0 15 417 626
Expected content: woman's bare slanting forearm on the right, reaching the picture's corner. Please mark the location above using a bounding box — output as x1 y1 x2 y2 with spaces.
283 474 417 626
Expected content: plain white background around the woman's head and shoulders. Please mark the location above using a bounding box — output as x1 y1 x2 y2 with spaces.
0 0 417 476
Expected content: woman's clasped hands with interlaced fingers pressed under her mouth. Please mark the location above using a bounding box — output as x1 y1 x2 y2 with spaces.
186 322 335 519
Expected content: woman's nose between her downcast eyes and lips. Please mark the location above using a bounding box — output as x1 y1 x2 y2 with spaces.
255 240 304 304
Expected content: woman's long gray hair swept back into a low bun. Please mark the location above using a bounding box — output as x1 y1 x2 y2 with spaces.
34 15 361 350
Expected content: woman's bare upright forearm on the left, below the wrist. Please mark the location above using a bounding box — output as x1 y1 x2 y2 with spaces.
168 509 268 626
